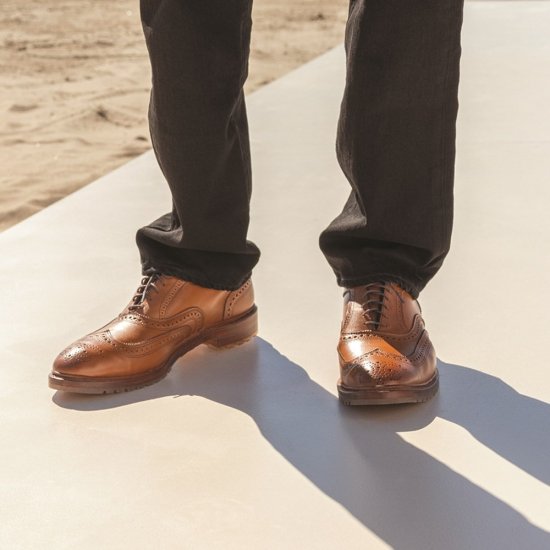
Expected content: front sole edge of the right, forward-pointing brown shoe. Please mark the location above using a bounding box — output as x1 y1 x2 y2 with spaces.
338 370 439 406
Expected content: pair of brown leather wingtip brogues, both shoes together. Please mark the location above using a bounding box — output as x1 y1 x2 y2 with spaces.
49 274 438 405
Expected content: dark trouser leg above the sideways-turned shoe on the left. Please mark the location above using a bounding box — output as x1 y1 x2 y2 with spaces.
136 0 259 289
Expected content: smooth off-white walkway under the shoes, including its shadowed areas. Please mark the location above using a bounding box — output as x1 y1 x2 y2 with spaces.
0 2 550 550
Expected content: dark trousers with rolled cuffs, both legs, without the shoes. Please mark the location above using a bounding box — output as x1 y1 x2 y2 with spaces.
137 0 463 296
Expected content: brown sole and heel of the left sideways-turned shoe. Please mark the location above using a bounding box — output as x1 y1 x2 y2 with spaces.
48 306 258 395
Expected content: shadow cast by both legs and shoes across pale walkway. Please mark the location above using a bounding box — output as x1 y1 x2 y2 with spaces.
54 338 550 550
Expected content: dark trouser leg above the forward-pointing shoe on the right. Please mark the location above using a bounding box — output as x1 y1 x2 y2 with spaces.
320 0 463 297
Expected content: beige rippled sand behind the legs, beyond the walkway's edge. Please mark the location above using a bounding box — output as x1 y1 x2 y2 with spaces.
0 0 347 230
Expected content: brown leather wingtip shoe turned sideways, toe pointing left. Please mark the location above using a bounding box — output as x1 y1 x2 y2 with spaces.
49 274 258 394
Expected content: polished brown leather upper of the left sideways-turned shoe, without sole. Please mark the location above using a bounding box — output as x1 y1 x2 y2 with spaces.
52 275 254 379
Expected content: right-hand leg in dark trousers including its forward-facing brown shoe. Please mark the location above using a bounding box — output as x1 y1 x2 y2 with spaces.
326 0 463 404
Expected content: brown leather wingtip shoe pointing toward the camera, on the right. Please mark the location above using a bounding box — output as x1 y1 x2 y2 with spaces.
338 282 439 405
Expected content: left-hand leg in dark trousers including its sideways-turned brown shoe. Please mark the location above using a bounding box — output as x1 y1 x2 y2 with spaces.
49 0 259 393
